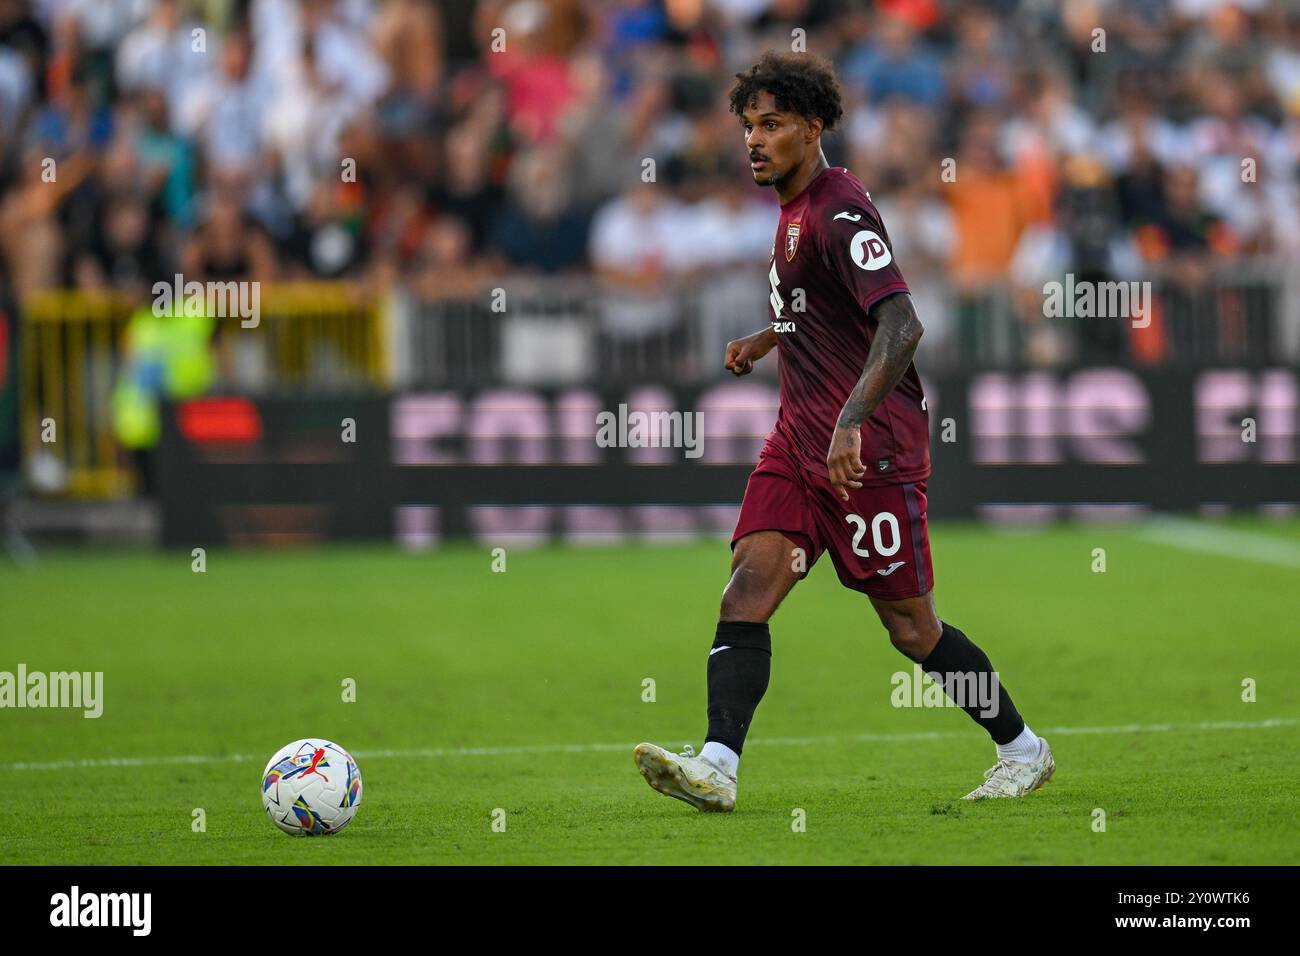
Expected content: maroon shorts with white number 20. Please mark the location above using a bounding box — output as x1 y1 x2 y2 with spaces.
732 442 935 601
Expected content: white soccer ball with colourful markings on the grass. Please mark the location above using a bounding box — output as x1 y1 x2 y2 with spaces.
261 737 361 836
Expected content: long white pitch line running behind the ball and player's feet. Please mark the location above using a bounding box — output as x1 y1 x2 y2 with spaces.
0 717 1300 771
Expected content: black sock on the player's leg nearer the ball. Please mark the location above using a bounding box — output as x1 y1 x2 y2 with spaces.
705 620 772 753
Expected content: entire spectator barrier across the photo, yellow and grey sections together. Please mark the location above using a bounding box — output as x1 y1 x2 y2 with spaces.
20 261 1300 497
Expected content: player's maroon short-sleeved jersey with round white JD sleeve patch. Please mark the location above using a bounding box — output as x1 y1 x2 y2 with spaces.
767 166 930 485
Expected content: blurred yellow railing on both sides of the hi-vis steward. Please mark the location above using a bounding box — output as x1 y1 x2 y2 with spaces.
18 282 390 498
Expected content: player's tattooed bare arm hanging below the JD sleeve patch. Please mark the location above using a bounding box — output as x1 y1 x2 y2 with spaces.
826 291 924 501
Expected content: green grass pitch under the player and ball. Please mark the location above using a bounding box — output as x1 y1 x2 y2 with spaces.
0 522 1300 865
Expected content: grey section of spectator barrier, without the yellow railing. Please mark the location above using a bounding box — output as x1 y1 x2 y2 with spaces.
394 260 1300 388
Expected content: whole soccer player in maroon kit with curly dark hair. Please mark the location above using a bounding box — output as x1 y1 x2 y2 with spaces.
633 52 1056 812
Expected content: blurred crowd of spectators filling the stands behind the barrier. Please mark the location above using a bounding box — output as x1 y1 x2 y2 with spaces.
0 0 1300 360
